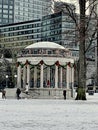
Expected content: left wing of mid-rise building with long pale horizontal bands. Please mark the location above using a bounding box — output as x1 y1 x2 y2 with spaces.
0 19 41 49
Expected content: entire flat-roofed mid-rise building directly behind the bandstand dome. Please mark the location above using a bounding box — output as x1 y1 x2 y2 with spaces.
0 12 78 56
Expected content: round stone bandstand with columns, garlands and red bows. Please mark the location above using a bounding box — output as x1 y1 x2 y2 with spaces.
17 42 74 99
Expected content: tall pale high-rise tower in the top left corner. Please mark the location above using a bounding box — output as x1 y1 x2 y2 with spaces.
0 0 52 25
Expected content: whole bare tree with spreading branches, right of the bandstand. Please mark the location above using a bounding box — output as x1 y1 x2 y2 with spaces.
53 0 98 100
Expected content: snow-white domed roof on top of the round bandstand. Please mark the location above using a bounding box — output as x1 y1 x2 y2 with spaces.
25 41 65 49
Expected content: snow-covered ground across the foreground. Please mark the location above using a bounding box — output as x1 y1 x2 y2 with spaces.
0 94 98 130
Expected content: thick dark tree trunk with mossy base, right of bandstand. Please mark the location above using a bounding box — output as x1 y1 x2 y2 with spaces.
76 0 86 100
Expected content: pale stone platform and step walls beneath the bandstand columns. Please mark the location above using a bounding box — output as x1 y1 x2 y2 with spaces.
5 88 72 99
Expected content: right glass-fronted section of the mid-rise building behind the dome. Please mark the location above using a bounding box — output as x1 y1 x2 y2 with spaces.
42 11 76 47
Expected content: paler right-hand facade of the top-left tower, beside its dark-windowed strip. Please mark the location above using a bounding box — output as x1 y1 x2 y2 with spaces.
14 0 51 22
